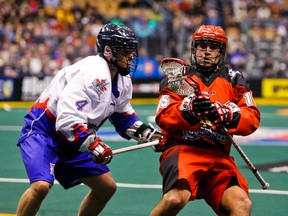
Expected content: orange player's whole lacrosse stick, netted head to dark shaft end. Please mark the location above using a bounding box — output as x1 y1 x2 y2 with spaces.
160 58 269 190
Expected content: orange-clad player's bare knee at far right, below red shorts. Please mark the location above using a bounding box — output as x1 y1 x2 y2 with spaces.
220 185 252 216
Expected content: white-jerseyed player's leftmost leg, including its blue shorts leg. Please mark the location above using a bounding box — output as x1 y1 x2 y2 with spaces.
16 134 58 216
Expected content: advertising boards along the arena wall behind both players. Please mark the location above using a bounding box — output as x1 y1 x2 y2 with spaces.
0 76 288 105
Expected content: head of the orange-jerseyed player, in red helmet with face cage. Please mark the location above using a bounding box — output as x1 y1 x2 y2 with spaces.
191 25 228 74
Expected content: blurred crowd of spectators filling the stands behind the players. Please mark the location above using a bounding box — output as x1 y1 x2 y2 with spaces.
0 0 288 79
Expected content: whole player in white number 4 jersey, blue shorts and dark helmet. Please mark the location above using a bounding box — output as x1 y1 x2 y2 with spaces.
16 24 161 216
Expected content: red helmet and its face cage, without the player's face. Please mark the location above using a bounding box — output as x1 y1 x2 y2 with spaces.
191 25 228 72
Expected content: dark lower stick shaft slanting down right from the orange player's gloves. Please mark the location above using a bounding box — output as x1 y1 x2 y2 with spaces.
225 128 270 190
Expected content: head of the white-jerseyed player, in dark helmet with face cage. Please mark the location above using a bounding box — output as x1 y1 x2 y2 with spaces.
97 24 138 76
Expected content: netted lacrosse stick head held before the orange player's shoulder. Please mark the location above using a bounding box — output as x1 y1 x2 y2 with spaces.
160 58 198 96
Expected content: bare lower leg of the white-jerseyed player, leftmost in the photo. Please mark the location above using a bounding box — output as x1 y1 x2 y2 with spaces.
16 181 52 216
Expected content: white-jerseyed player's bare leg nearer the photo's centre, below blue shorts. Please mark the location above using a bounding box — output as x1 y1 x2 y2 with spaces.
78 172 117 216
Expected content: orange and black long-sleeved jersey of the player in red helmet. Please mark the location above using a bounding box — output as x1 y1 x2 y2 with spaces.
156 66 260 152
